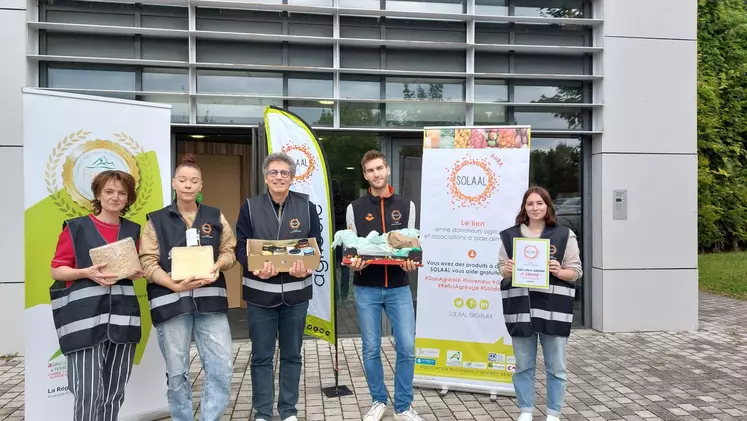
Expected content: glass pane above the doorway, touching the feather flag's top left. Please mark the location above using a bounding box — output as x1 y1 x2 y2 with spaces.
197 98 283 125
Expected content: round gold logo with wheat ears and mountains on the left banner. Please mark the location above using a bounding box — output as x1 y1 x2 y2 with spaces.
44 130 154 218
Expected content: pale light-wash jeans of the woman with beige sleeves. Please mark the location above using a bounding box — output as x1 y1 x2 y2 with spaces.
156 313 233 421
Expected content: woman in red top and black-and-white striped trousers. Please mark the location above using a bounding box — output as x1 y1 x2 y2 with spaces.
50 171 142 421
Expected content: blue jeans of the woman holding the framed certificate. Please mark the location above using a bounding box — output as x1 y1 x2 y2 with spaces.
511 334 568 417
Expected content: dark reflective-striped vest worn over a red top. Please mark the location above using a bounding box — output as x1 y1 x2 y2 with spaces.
49 216 141 355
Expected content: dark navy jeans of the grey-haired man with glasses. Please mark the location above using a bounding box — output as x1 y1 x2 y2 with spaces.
246 301 309 421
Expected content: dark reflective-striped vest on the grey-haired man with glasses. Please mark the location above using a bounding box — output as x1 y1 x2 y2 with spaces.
242 191 317 307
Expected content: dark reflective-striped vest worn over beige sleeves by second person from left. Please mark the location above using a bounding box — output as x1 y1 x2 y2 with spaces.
147 203 231 326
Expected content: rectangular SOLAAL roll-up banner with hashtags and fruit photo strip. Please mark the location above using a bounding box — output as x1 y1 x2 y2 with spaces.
415 126 530 396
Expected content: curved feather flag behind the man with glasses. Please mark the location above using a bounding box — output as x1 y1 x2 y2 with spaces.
265 107 336 344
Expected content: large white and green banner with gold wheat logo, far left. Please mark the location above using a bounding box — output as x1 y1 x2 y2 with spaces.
23 89 171 421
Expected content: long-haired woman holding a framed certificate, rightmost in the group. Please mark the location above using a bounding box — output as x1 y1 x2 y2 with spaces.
499 187 583 421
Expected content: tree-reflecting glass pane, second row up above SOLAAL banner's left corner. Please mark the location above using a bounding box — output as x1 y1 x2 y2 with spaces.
386 77 464 101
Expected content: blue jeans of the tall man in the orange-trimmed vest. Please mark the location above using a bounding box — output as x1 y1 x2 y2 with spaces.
355 285 415 412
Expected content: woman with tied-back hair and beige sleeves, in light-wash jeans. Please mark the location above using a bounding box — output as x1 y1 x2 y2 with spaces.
140 154 236 421
